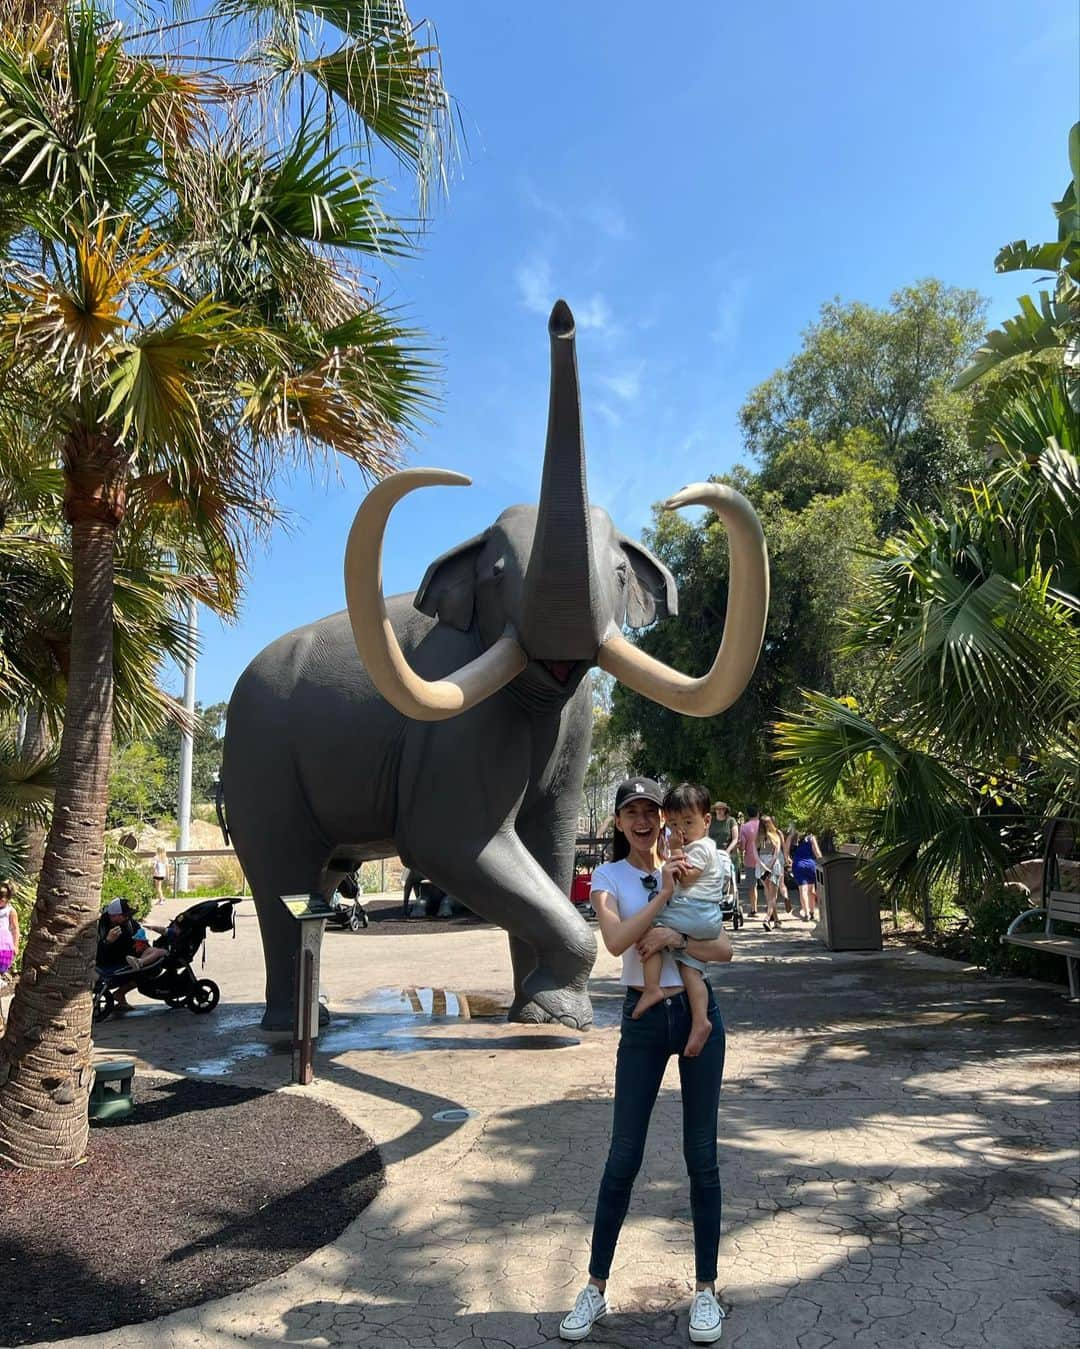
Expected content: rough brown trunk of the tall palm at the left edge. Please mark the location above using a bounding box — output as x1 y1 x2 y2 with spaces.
0 500 116 1168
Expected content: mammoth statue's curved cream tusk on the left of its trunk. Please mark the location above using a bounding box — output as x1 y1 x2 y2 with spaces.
345 468 527 722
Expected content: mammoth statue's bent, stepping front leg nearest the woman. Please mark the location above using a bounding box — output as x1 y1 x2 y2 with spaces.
414 831 596 1029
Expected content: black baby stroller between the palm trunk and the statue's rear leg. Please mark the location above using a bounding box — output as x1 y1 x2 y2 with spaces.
94 898 241 1021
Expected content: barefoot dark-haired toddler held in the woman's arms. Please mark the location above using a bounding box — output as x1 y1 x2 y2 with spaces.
634 782 731 1059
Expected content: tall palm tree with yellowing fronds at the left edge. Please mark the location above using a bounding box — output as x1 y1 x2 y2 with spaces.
0 0 449 1167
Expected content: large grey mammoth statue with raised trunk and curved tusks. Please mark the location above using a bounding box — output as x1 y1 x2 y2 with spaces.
222 301 769 1029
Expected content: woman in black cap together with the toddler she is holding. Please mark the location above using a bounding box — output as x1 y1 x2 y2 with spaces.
560 778 731 1344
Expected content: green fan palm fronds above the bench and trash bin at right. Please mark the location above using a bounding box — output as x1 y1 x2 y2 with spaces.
777 444 1080 927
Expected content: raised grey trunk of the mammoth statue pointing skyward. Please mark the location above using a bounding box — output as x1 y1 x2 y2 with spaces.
519 299 603 665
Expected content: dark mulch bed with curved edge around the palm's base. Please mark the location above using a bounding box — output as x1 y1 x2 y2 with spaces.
0 1075 384 1345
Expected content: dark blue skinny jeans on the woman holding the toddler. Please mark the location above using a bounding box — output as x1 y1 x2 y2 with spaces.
589 979 724 1283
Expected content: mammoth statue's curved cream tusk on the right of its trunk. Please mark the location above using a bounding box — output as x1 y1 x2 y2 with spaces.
596 483 769 716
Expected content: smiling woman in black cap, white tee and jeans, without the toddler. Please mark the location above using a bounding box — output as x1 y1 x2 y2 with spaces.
560 778 731 1344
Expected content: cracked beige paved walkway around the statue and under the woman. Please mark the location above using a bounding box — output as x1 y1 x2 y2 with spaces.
37 907 1080 1349
